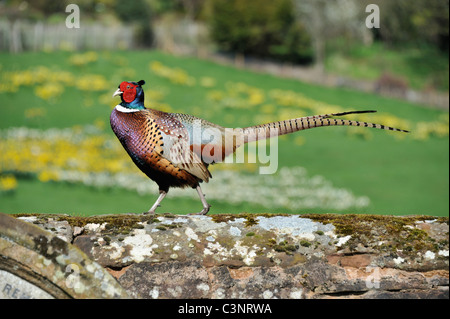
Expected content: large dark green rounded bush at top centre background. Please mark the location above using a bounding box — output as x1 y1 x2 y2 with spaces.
208 0 312 63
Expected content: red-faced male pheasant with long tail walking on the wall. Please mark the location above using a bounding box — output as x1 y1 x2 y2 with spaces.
110 80 408 215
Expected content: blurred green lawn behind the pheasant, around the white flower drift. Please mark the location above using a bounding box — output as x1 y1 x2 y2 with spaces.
0 51 449 216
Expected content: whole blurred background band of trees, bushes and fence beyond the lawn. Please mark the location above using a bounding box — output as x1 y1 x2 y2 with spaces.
0 0 449 91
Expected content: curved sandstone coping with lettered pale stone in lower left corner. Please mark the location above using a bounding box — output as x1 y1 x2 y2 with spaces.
0 214 129 299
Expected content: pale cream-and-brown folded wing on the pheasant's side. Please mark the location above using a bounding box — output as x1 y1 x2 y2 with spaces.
147 112 211 182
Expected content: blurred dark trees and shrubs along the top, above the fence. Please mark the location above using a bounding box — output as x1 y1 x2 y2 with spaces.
0 0 449 55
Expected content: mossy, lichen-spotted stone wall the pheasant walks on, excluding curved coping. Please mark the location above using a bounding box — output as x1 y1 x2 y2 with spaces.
0 214 449 299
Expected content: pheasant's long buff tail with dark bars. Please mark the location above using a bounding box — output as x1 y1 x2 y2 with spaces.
242 110 409 143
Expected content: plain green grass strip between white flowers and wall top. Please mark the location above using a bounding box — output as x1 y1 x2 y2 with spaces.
0 180 326 216
